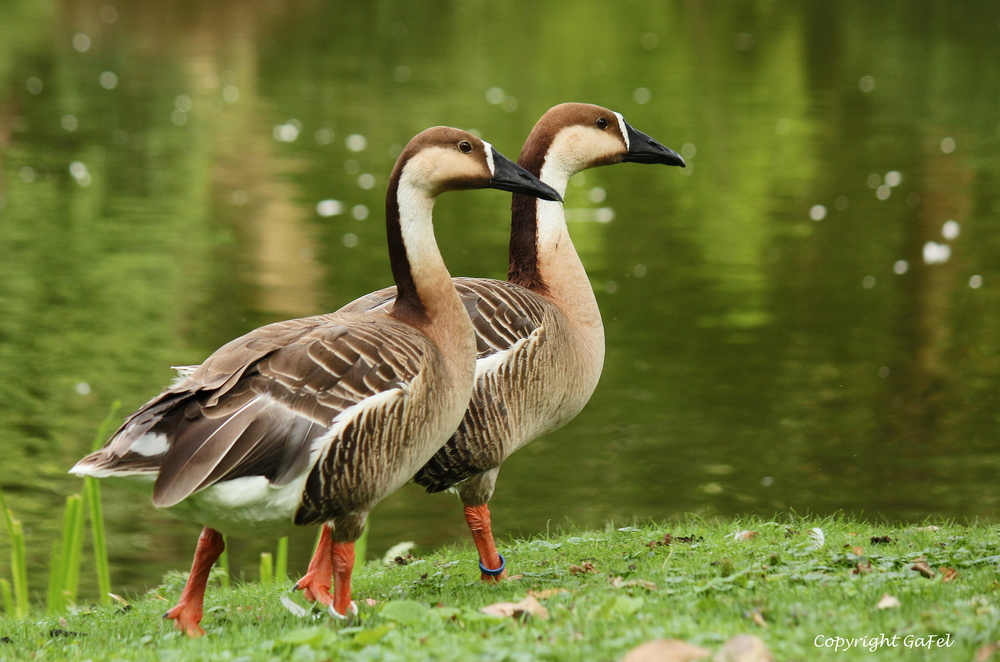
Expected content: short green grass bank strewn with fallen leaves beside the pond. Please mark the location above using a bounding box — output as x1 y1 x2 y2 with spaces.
0 518 1000 661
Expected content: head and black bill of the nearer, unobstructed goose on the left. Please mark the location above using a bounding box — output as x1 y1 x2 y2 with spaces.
396 126 562 202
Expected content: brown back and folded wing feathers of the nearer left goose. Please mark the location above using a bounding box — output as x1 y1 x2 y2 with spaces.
73 314 429 507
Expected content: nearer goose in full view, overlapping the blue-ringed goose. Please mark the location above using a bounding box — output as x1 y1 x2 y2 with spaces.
70 127 561 636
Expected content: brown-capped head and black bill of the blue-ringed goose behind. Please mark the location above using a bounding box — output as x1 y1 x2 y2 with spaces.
518 103 685 181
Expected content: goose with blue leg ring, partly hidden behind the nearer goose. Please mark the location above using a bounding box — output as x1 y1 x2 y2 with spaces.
298 103 685 602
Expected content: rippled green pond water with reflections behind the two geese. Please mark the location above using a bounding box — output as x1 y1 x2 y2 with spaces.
0 0 1000 594
